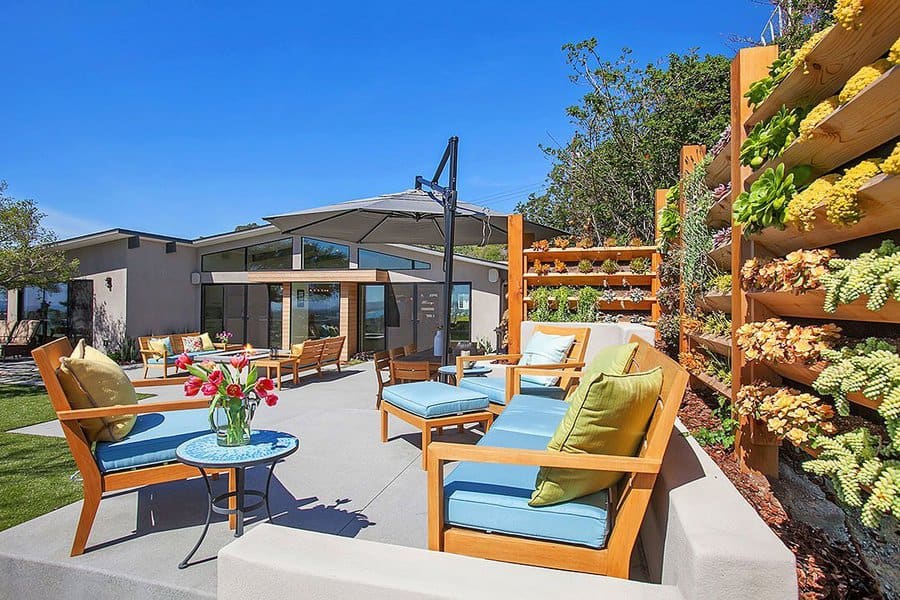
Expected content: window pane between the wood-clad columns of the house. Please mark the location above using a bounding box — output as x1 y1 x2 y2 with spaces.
291 283 341 344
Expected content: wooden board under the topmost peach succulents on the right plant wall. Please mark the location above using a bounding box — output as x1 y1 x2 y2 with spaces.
747 290 900 323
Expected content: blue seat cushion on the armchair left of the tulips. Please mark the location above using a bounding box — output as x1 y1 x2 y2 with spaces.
94 408 210 473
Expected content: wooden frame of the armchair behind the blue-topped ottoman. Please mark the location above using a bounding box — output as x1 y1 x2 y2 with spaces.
456 324 591 414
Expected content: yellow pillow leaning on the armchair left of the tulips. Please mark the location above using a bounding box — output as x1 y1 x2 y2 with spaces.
56 340 137 442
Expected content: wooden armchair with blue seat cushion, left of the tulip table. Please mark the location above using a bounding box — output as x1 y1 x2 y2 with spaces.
31 338 235 556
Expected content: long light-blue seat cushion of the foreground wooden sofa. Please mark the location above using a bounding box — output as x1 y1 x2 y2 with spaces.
444 426 608 548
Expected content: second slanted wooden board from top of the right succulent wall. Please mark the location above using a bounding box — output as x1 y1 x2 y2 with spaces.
744 66 900 189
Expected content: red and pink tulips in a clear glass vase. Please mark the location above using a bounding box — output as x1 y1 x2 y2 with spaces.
175 352 278 446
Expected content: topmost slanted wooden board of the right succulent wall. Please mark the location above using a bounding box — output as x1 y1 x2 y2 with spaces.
745 0 900 130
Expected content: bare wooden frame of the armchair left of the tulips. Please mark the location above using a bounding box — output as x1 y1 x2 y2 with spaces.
31 338 234 556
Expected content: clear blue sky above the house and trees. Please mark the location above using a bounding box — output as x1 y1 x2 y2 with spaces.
0 0 769 237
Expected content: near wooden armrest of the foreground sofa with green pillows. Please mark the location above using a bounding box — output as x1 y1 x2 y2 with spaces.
428 442 662 474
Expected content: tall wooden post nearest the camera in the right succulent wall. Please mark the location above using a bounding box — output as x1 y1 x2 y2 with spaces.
731 46 778 477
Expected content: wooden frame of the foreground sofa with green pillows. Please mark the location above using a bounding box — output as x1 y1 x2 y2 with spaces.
428 336 688 578
